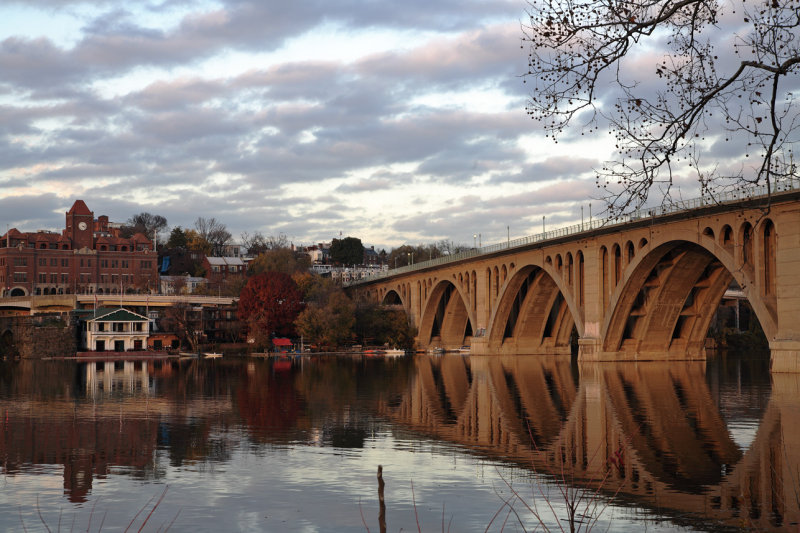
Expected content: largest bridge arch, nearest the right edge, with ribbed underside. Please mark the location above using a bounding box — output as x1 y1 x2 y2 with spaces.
601 224 777 358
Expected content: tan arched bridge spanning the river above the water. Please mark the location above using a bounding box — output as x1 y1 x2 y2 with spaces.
347 183 800 372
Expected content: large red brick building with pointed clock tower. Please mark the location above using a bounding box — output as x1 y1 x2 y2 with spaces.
0 200 158 297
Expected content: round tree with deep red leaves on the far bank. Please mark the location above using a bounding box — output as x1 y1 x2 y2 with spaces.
237 272 303 341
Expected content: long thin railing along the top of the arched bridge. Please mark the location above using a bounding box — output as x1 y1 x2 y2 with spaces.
344 178 800 287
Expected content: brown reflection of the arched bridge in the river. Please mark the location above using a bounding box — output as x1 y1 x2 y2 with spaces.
380 354 800 529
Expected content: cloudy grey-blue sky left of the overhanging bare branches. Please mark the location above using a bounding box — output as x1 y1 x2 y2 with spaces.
0 0 676 248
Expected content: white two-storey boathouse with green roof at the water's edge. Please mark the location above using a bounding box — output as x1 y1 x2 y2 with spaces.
81 308 150 352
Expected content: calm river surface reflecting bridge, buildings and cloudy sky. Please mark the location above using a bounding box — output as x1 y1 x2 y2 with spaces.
0 354 788 532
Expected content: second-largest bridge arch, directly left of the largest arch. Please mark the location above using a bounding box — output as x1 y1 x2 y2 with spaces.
487 260 584 354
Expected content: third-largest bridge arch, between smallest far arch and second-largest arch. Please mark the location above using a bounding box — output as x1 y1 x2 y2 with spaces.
418 280 475 349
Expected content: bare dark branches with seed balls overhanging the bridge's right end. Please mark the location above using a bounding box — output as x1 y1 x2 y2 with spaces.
522 0 800 215
